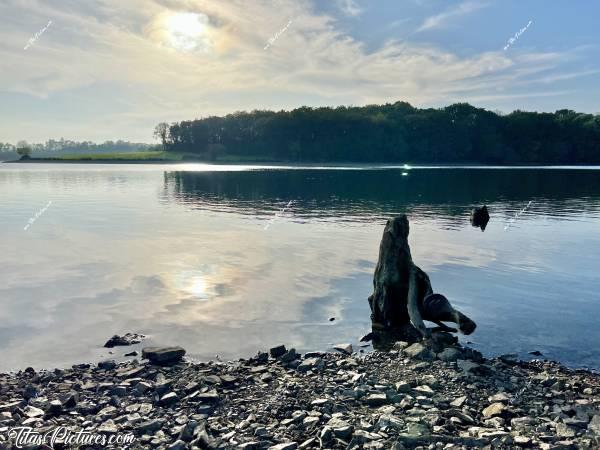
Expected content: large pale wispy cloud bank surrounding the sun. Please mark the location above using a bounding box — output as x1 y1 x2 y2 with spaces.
0 0 592 141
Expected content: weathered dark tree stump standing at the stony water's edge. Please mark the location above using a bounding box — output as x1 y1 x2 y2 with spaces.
369 215 476 338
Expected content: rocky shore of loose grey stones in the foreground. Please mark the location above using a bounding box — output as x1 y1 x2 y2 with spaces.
0 342 600 450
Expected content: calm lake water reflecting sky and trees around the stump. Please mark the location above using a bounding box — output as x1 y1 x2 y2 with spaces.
0 164 600 371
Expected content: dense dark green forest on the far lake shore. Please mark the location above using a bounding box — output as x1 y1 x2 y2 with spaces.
155 102 600 164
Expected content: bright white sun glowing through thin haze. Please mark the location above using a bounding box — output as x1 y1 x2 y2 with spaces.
164 12 210 52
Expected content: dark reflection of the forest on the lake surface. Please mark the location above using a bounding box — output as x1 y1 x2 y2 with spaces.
161 169 600 227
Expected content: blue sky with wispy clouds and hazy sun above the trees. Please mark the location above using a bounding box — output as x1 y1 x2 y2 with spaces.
0 0 600 143
